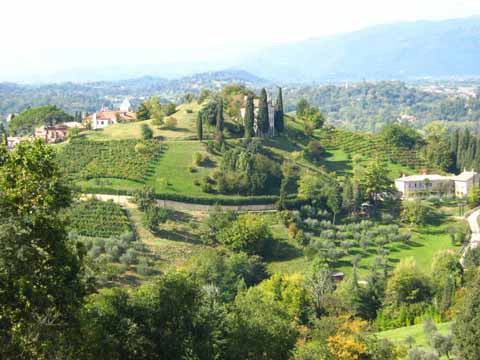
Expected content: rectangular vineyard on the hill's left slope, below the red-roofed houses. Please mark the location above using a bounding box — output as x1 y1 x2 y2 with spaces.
58 140 162 182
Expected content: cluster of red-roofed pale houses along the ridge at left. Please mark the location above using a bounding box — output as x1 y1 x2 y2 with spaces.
7 99 137 150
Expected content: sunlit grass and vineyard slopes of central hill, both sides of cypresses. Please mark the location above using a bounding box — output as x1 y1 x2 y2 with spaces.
59 102 430 202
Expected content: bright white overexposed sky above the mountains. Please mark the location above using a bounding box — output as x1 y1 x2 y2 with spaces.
0 0 480 81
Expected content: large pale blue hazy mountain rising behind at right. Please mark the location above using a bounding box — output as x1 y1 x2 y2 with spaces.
242 16 480 82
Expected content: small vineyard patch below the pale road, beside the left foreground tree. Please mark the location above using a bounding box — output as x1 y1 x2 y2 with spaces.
63 199 132 238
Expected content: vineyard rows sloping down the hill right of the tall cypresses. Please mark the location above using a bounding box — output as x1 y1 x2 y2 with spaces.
322 128 426 169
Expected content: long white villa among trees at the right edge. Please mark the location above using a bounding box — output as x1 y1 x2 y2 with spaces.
395 170 480 198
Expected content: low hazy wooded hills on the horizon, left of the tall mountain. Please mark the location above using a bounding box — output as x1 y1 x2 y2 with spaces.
0 69 270 115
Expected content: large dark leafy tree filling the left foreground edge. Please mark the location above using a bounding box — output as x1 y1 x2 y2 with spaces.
0 141 87 359
